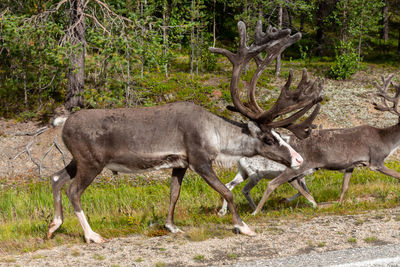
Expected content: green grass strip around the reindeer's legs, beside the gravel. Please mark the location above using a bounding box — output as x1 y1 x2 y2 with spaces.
0 162 400 256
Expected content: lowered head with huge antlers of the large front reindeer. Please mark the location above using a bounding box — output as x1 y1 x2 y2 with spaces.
209 21 323 170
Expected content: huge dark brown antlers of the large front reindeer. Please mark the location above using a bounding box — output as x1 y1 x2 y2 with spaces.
210 21 323 138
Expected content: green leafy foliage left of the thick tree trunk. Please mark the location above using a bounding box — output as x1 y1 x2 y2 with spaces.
0 13 68 116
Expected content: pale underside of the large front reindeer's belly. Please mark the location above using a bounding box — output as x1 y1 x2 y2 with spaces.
105 154 188 173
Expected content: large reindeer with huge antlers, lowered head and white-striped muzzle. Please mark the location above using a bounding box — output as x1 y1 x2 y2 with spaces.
48 19 322 243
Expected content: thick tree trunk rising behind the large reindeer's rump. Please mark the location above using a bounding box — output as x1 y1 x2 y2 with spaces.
65 0 86 111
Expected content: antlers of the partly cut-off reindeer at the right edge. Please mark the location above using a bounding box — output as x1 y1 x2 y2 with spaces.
373 74 400 116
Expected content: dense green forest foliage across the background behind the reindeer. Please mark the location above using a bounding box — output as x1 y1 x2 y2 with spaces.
0 0 400 118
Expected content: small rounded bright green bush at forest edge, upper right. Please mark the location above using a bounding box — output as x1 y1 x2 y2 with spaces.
329 42 359 80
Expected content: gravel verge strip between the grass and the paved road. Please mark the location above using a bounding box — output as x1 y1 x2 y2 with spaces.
0 208 400 266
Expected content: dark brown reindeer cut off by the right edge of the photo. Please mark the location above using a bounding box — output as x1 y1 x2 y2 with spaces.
253 75 400 215
